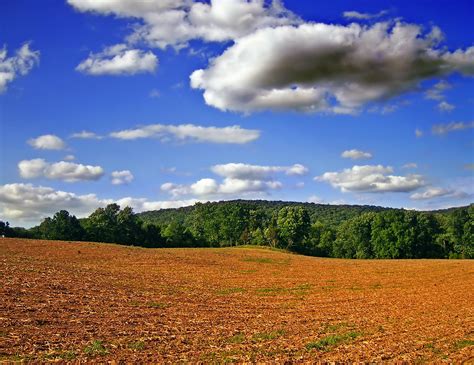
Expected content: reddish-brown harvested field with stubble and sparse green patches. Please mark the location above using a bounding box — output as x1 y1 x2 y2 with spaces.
0 239 474 363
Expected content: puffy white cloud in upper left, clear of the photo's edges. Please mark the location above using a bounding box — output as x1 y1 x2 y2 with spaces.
76 44 158 76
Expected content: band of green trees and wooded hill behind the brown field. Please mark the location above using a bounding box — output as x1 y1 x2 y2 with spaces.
0 200 474 259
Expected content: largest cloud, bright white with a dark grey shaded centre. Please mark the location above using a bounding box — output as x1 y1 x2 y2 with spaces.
190 22 474 114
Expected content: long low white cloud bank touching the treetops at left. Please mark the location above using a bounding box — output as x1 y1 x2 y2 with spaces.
0 184 202 226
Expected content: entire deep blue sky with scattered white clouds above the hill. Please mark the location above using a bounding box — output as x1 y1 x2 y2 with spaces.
0 0 474 227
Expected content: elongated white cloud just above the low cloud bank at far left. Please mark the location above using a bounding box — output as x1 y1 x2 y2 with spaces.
18 158 104 182
